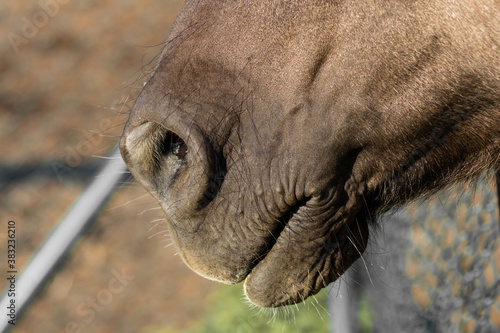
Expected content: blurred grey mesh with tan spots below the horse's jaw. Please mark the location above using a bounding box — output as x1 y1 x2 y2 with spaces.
342 177 500 332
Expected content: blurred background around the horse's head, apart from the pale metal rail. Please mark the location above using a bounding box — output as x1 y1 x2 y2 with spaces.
0 0 500 333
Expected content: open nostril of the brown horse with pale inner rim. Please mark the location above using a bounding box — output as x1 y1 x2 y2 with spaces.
120 110 211 226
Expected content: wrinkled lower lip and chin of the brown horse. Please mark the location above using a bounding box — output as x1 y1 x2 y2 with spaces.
240 198 368 307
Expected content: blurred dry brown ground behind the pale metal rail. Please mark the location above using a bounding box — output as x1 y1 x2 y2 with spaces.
0 0 219 333
